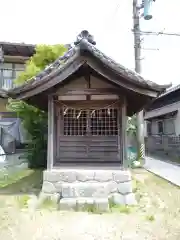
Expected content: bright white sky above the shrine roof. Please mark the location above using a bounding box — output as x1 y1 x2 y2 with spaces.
0 0 180 84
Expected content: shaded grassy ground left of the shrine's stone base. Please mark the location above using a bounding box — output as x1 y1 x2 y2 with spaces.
0 169 43 195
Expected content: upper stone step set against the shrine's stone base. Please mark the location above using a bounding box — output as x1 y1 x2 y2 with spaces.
61 182 110 198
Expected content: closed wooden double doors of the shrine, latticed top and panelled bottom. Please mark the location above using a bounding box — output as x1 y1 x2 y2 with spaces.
58 108 120 162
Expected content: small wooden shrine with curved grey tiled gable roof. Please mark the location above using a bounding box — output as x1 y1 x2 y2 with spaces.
10 31 169 210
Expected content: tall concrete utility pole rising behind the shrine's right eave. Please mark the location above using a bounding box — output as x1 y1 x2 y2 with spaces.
133 0 155 163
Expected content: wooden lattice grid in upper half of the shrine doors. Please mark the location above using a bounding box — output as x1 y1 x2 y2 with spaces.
63 108 118 136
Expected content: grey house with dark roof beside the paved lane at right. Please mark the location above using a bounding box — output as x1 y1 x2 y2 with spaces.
144 85 180 159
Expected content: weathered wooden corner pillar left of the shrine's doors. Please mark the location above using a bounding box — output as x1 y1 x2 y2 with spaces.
47 95 55 169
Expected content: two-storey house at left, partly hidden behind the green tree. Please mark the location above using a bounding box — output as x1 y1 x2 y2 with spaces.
0 42 71 152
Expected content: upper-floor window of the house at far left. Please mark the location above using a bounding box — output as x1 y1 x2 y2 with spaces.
0 63 24 90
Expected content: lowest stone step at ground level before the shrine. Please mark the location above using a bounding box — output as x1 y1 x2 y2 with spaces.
59 198 109 212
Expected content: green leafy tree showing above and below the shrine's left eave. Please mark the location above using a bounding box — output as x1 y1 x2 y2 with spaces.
7 44 67 168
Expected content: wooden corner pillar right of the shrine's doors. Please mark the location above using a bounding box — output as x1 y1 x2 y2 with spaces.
121 98 128 168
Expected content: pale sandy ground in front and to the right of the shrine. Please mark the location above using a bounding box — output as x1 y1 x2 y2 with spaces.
0 170 180 240
